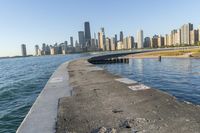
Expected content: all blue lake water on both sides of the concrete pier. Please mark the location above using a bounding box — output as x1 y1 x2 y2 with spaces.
0 54 200 133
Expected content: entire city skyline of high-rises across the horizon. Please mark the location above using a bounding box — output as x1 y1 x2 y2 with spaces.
22 22 200 56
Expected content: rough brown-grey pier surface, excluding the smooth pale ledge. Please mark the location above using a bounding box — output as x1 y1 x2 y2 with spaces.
57 60 200 133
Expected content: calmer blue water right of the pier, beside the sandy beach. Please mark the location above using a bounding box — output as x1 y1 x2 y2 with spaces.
99 58 200 105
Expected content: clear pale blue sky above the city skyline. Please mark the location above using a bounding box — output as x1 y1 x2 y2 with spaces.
0 0 200 57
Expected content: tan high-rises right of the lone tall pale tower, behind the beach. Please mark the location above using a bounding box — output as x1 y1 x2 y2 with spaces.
152 23 200 48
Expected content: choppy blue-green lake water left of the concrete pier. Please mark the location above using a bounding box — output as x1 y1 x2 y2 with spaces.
0 54 87 133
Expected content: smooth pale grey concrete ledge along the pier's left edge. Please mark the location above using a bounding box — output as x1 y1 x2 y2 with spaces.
17 63 71 133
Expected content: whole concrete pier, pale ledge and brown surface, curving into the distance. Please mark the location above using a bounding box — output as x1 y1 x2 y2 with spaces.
17 50 200 133
